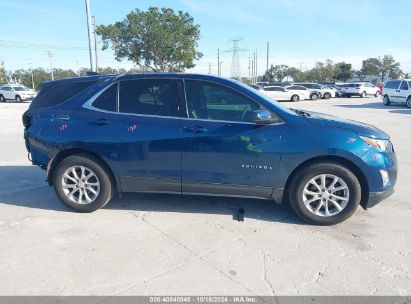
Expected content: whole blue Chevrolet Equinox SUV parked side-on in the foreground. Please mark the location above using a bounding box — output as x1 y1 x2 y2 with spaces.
23 74 397 225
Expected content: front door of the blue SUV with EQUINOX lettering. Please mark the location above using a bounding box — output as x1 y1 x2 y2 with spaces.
182 80 282 198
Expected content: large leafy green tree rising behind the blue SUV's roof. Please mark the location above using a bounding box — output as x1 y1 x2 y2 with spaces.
96 7 203 72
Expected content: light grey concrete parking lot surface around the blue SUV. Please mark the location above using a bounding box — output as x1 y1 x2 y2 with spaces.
0 98 411 295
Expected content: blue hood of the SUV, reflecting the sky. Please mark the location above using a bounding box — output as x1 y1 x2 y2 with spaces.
302 111 390 139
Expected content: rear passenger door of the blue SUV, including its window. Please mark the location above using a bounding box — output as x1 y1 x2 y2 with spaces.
82 79 181 193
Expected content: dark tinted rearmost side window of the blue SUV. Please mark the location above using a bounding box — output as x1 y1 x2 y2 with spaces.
29 79 97 109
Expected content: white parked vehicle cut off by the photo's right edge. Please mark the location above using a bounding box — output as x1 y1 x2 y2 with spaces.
382 79 411 108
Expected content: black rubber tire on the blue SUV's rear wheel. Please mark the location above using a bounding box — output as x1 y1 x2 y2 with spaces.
53 155 114 212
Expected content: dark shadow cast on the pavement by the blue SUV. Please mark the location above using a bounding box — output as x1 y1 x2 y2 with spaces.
0 166 304 225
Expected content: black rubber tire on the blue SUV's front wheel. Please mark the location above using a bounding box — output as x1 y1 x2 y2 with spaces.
287 163 361 225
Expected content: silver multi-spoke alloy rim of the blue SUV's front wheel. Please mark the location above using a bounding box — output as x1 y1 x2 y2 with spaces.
302 174 350 217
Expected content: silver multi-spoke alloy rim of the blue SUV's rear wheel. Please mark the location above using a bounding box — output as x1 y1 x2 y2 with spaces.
61 166 100 205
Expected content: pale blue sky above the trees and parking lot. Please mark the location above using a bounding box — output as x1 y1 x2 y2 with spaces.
0 0 411 76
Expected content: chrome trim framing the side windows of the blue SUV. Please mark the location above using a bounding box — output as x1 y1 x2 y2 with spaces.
82 77 285 126
